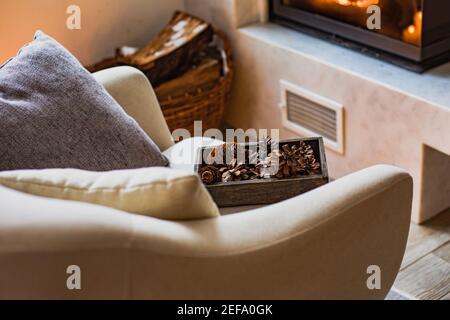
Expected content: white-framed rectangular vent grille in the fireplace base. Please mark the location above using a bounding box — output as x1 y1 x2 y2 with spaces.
280 80 344 153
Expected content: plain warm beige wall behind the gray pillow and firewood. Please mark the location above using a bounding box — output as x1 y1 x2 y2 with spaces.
0 0 184 64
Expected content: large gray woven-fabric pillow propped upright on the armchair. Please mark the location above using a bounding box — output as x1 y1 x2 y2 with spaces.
0 32 168 171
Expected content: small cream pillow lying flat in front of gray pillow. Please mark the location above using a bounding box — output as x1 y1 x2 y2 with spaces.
0 167 219 220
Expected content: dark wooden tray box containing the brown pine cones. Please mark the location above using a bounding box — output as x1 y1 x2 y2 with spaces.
195 137 329 207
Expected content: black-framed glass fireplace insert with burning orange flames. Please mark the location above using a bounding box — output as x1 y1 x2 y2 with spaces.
268 0 450 72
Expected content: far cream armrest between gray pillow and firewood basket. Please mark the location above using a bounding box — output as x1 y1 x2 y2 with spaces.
94 67 174 151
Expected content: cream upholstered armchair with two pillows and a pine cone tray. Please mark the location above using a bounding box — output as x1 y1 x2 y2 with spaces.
0 67 412 299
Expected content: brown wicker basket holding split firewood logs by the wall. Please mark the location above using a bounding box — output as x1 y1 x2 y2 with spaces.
159 30 233 134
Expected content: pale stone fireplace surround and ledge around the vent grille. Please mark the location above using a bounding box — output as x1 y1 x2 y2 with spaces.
185 0 450 223
